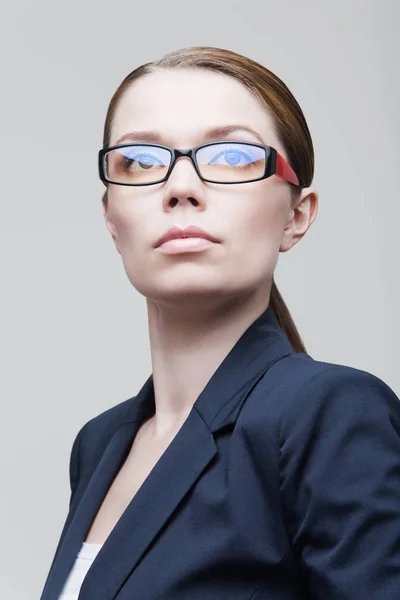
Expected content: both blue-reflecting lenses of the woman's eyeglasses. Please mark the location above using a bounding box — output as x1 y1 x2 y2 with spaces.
105 142 266 185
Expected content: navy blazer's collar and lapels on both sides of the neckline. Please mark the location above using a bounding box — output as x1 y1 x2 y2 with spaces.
41 307 293 600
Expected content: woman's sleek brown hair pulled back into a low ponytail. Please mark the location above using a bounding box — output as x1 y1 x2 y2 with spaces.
103 46 314 353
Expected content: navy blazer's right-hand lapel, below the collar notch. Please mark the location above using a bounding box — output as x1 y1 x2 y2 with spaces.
79 409 217 600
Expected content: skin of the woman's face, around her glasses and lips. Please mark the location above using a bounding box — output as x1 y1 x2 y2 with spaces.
105 69 316 303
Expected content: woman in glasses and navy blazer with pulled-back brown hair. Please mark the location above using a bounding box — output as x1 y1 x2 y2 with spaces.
41 47 400 600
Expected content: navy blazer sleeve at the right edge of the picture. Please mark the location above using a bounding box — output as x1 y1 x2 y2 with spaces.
280 365 400 600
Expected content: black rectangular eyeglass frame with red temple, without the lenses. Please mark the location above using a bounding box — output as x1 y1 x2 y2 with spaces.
98 140 300 187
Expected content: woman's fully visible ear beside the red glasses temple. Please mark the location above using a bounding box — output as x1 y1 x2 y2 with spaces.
279 187 318 252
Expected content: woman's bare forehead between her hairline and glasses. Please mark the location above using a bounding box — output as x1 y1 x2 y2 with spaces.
110 69 283 150
